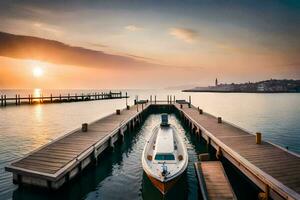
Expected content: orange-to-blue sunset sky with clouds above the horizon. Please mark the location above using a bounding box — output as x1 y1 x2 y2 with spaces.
0 0 300 89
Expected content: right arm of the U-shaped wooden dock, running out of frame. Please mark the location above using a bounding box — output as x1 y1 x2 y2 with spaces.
175 104 300 199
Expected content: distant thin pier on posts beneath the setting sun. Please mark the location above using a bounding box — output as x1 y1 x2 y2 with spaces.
0 91 128 107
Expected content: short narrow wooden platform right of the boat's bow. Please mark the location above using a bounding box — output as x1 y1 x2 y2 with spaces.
195 161 236 200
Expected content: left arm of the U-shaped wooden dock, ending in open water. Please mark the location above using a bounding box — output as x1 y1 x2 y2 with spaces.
5 104 149 189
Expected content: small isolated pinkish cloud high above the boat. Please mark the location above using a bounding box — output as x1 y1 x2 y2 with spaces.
169 28 198 43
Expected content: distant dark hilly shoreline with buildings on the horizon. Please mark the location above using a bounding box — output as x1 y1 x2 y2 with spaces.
182 79 300 93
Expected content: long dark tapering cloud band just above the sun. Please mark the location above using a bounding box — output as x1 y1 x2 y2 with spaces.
0 32 161 69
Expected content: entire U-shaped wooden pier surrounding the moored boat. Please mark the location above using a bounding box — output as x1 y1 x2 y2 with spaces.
6 99 300 199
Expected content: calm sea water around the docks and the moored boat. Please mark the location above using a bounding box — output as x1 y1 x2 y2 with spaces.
0 90 300 199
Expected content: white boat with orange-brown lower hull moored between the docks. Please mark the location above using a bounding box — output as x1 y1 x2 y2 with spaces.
142 114 188 194
